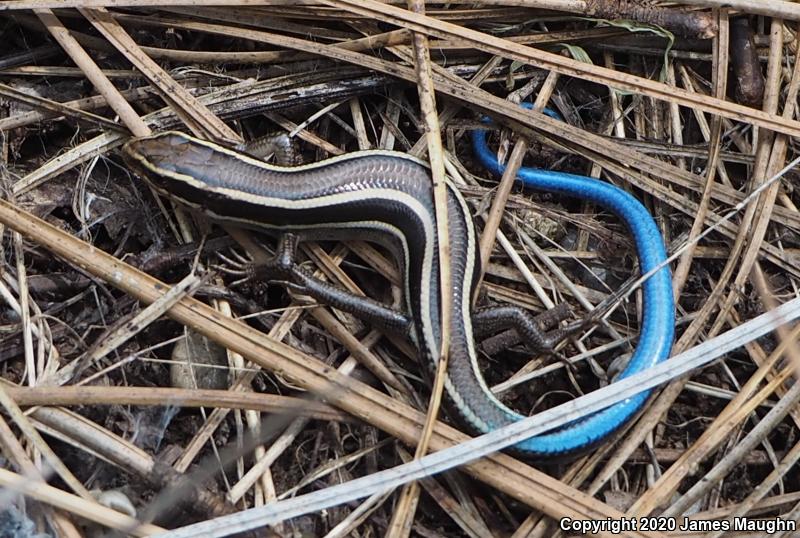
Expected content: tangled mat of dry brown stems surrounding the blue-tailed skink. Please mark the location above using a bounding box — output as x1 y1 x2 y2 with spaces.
0 0 800 538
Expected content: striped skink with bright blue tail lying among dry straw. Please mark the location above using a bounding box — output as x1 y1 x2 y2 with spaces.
123 117 672 459
